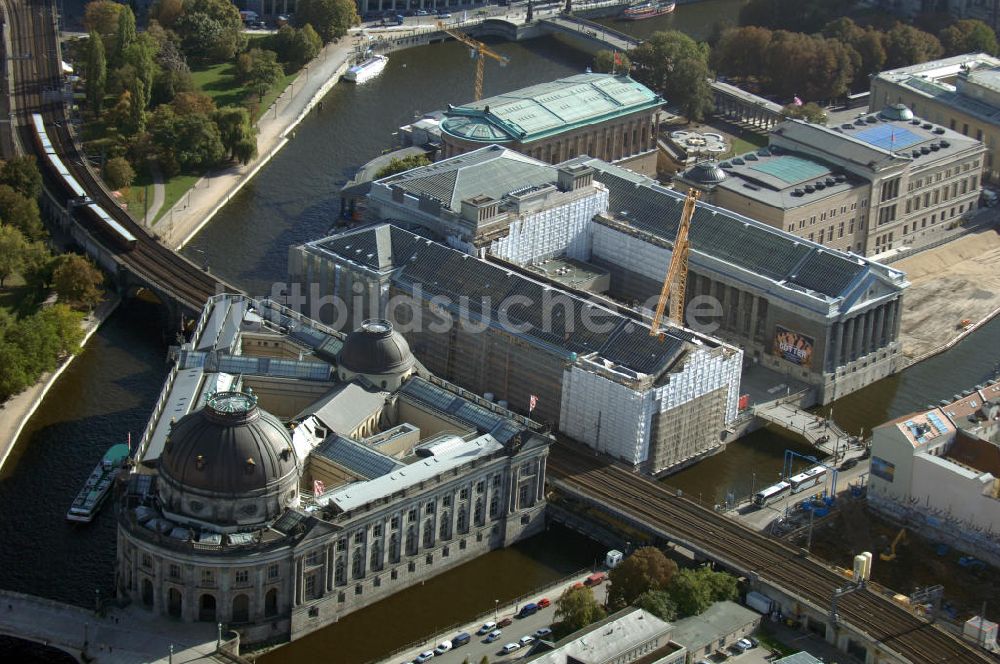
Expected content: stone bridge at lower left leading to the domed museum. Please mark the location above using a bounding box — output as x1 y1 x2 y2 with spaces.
0 590 218 664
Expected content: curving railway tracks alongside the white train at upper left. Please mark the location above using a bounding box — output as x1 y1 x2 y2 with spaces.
4 0 239 311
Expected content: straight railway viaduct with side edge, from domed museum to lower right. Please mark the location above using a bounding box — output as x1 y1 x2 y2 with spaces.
547 443 994 664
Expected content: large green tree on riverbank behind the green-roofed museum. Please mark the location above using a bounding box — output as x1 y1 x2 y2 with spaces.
632 30 712 120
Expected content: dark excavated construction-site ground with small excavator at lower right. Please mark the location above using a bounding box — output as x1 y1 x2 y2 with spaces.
795 501 1000 621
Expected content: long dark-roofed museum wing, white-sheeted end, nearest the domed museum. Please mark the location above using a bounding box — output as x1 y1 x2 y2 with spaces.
289 224 742 473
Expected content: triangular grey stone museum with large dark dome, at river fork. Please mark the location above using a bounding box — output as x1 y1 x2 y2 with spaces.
122 295 550 643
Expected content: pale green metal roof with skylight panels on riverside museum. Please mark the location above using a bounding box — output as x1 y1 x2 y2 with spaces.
441 74 664 143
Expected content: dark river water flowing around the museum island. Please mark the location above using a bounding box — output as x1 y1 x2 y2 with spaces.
0 0 1000 662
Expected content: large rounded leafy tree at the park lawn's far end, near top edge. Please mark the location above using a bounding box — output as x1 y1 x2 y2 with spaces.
173 0 246 62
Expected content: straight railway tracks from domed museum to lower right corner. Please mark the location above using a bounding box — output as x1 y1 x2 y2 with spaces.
548 444 997 664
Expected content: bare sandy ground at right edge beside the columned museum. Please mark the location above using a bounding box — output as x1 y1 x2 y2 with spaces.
892 228 1000 358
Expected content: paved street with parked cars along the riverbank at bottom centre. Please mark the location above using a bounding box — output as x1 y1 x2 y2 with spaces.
385 576 608 664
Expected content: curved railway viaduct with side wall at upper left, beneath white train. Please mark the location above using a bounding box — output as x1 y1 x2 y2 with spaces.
0 0 239 326
